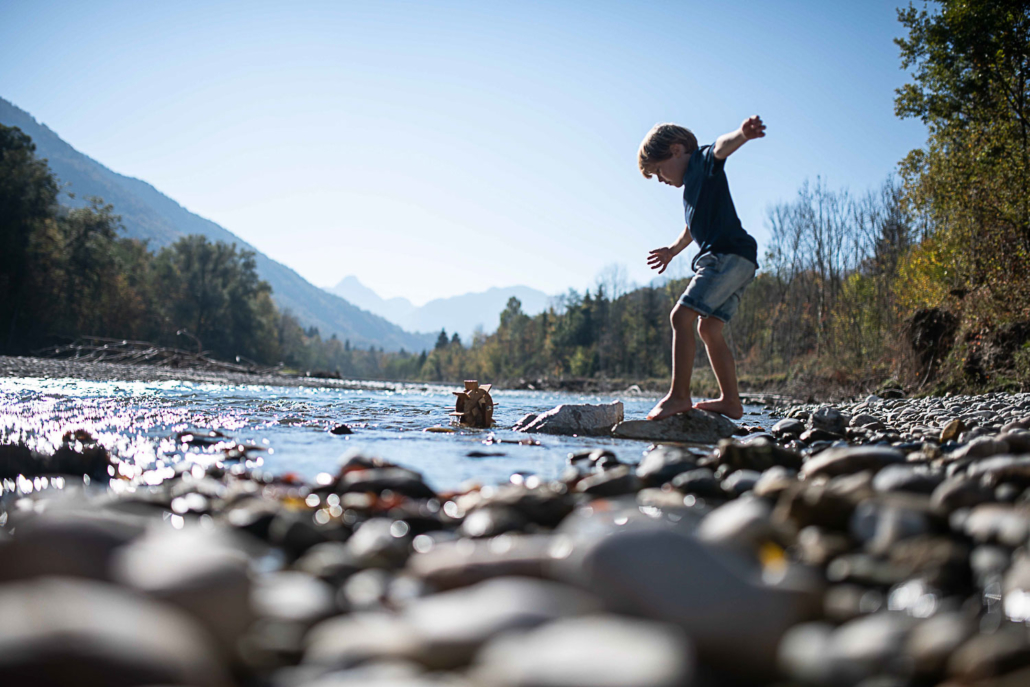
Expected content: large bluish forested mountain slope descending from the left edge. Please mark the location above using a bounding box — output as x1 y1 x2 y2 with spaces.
0 98 436 351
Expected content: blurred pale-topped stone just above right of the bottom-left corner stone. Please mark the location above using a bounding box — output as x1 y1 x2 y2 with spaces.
111 527 252 654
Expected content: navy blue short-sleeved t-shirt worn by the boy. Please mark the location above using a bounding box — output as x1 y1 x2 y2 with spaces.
683 145 758 270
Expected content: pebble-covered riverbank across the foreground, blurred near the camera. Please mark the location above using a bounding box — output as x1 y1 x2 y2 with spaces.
0 394 1030 687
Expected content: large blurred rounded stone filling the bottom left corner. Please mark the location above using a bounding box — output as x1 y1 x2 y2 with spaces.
0 578 234 687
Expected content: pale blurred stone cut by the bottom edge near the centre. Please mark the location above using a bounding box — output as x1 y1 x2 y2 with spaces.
472 615 695 687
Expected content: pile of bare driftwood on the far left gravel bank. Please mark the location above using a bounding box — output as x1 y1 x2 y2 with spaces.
35 337 279 374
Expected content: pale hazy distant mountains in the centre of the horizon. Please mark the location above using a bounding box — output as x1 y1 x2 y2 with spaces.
328 276 551 344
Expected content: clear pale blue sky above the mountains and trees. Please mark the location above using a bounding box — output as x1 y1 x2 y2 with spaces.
0 0 926 304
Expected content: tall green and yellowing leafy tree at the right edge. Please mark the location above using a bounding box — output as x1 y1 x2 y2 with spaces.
895 0 1030 320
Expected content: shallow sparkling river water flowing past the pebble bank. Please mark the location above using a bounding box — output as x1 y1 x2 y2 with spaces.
0 378 769 489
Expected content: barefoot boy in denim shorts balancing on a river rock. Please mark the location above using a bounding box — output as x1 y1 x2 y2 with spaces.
637 115 765 420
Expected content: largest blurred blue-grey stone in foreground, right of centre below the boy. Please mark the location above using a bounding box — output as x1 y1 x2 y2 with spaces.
553 525 819 677
